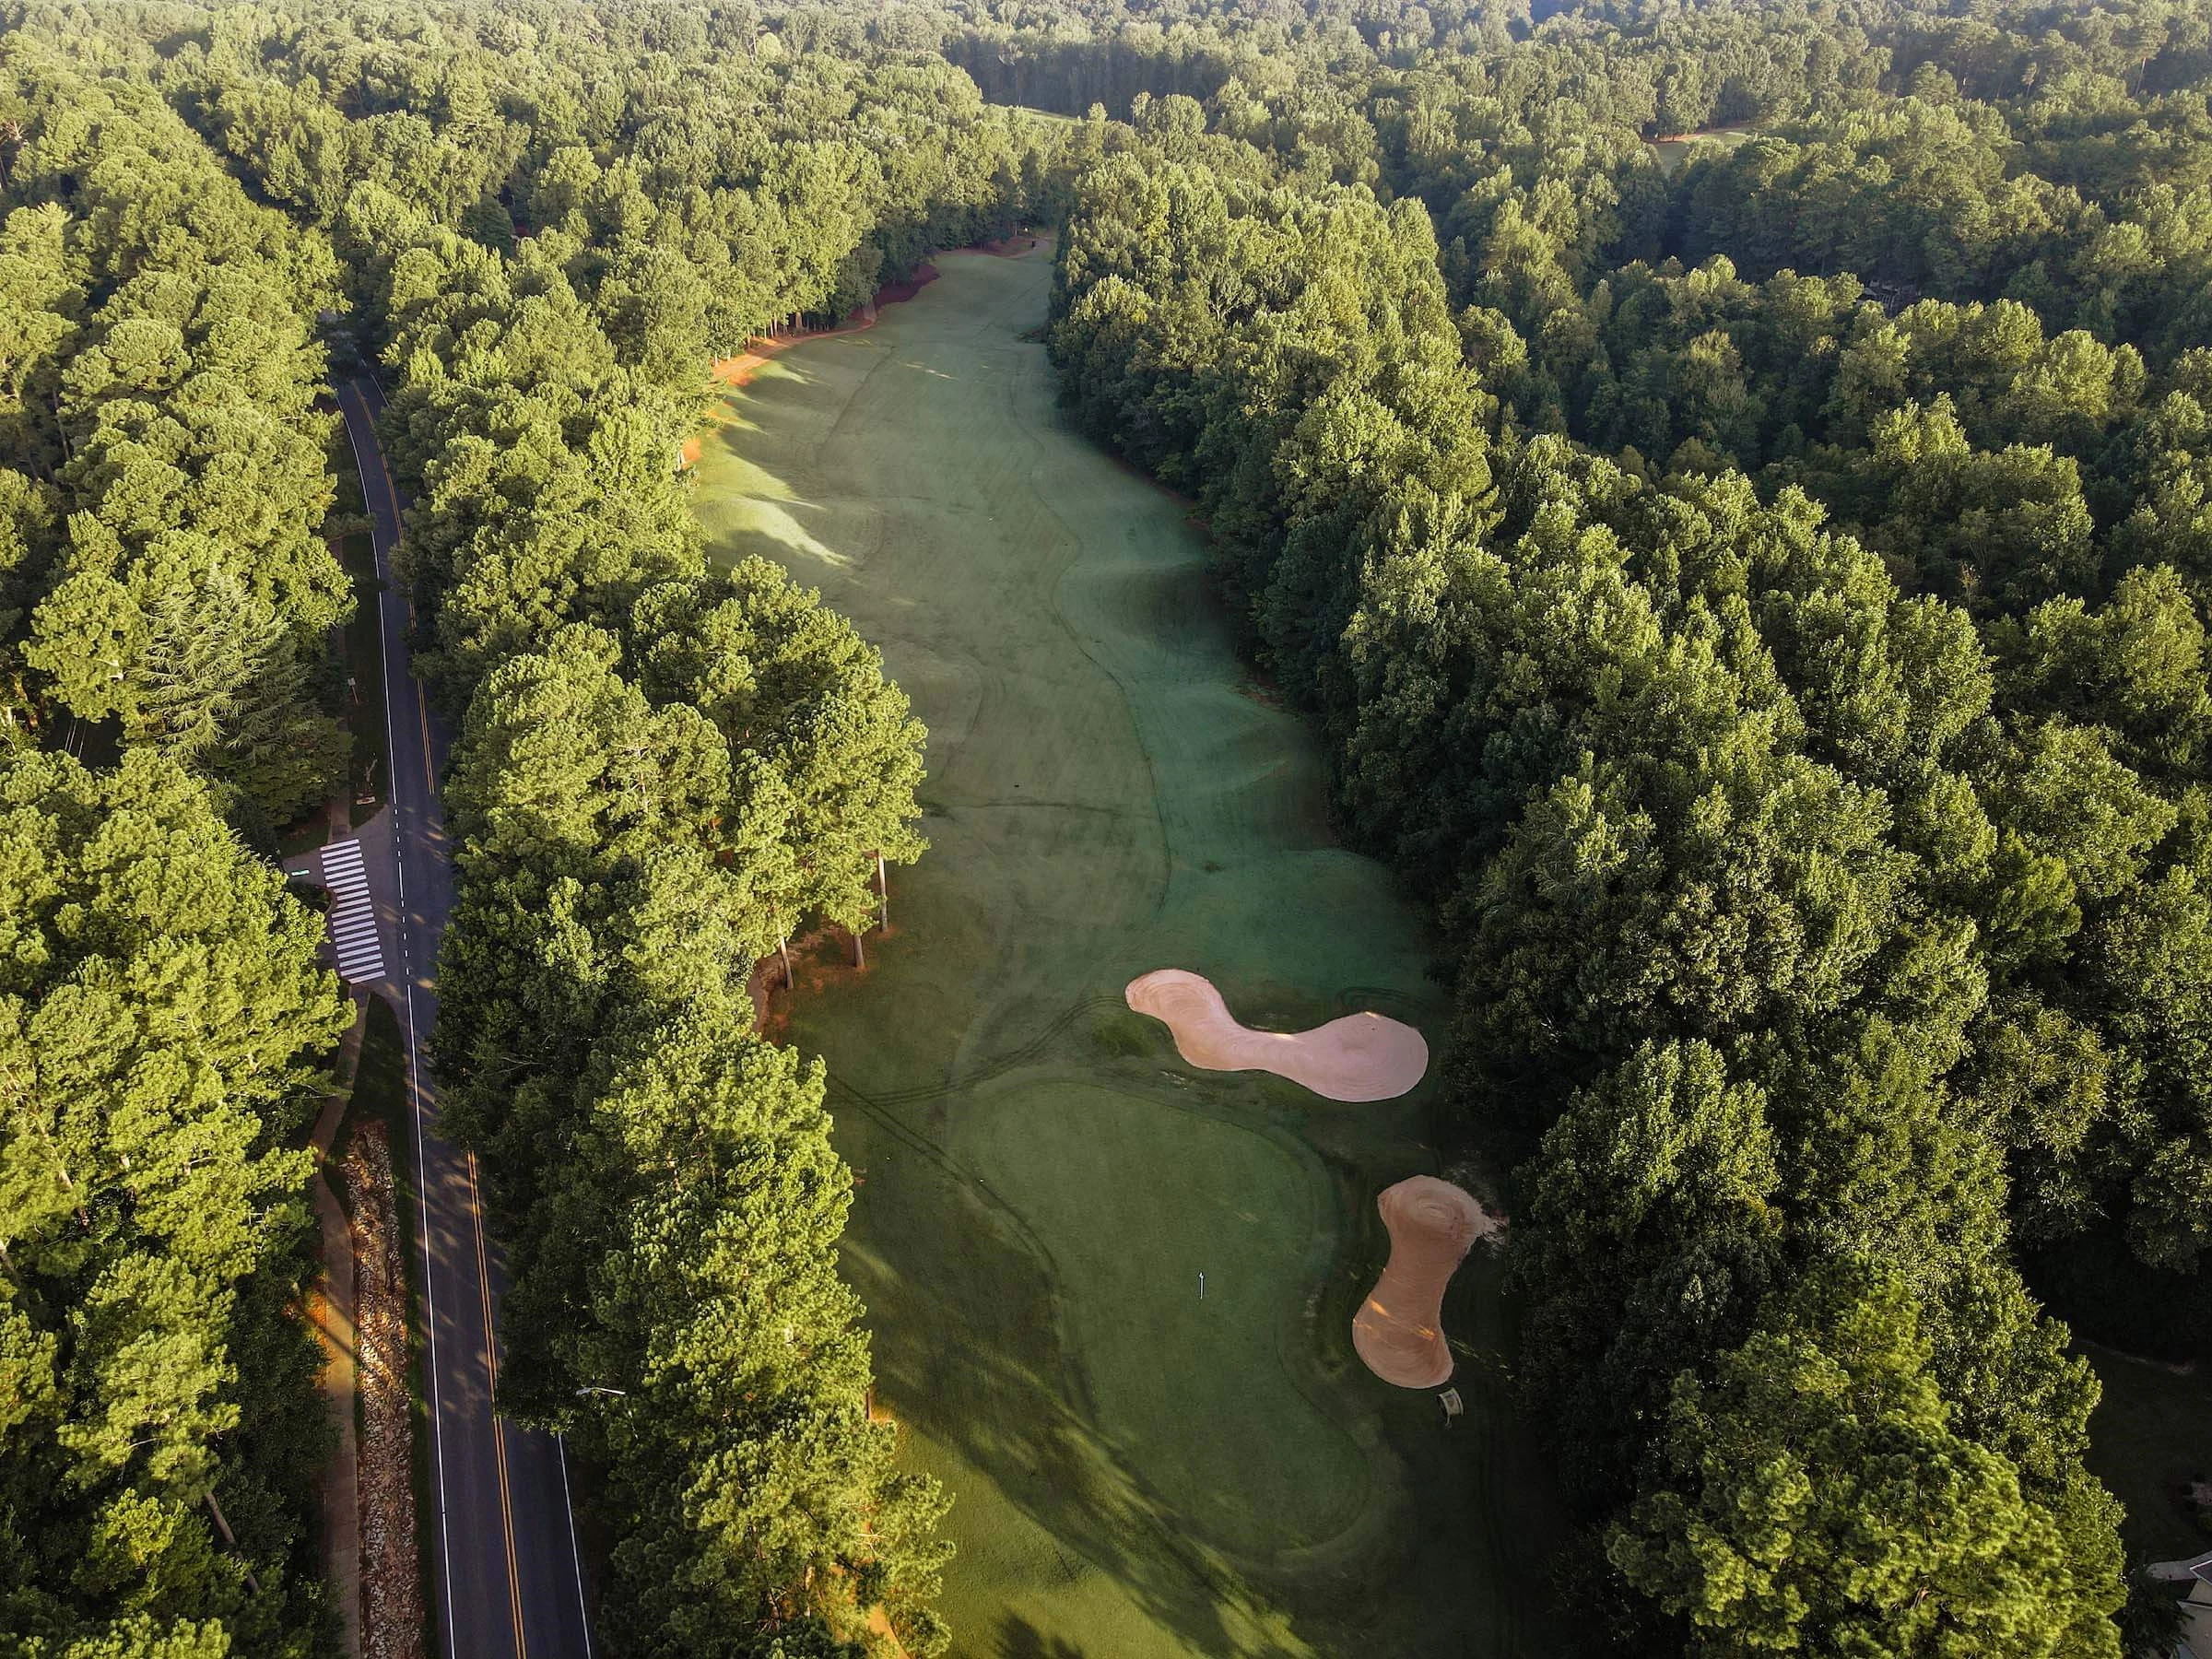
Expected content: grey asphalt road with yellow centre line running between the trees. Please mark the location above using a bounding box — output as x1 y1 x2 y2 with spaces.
338 381 591 1659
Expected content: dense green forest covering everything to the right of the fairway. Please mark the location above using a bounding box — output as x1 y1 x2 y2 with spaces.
1044 6 2212 1654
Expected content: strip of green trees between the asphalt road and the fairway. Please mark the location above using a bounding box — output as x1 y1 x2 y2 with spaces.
190 6 1079 1654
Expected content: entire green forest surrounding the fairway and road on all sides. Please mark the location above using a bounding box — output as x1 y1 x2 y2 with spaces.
0 0 2212 1659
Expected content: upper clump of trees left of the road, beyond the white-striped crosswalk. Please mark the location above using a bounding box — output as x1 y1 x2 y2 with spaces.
0 35 352 823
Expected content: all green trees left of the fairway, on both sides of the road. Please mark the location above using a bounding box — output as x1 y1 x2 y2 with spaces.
0 5 1070 1659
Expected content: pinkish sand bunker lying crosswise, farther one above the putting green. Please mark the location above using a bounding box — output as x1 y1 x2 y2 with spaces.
1128 969 1429 1100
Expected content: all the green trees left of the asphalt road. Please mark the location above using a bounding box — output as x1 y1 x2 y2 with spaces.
0 31 349 1659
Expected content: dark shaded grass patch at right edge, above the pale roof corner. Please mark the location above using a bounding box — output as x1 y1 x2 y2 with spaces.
2081 1343 2212 1561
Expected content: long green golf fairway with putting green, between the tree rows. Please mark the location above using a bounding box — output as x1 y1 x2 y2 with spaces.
697 250 1575 1659
